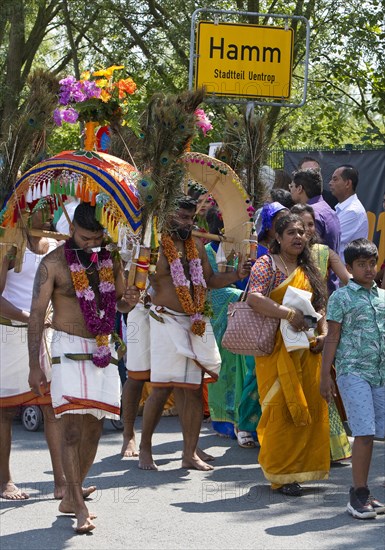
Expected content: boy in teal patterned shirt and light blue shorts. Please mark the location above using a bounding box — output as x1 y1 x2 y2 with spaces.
320 239 385 519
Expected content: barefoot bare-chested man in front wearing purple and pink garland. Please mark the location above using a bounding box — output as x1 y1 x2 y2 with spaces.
28 203 138 533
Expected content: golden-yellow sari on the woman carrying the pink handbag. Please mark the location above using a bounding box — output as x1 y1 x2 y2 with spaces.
256 267 330 489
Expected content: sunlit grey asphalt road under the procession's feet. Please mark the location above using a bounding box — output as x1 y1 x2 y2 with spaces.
0 417 385 550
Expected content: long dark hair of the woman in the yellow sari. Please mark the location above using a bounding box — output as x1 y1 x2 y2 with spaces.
270 213 327 311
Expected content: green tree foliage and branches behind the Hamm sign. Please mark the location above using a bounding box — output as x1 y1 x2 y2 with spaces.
0 0 385 177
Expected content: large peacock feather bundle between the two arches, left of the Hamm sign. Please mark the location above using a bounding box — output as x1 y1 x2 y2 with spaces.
112 89 204 242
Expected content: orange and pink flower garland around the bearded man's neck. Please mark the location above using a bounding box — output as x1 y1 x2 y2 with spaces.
161 234 207 336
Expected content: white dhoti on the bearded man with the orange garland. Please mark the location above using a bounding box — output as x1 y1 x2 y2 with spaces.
150 306 221 389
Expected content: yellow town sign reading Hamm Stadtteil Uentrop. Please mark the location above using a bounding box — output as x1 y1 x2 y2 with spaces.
195 21 294 99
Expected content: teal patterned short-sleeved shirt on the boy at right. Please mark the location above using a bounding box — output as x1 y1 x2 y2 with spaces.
326 280 385 386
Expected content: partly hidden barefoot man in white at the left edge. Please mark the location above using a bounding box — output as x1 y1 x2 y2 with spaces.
0 205 66 500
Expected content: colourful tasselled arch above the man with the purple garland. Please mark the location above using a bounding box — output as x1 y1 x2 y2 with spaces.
0 151 141 276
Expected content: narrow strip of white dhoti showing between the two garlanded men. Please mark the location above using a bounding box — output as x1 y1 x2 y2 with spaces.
125 303 151 380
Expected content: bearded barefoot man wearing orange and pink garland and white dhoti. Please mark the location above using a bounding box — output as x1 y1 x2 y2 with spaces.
139 197 251 470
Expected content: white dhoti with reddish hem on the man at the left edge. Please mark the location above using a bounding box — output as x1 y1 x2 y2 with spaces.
0 319 51 407
